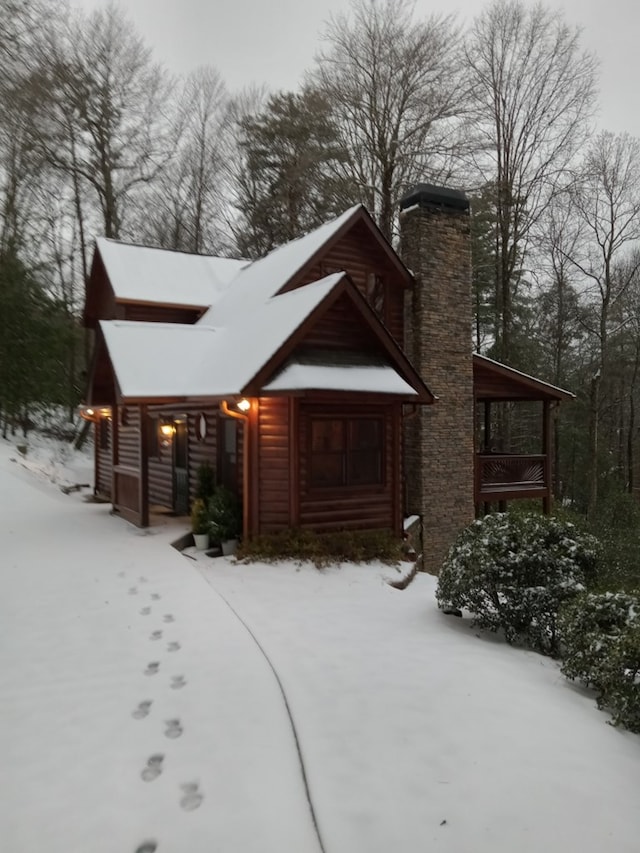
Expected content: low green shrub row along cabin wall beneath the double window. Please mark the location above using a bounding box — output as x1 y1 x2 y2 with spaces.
238 528 402 568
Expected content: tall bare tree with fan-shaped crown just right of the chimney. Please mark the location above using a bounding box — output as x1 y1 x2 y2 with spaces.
466 0 597 362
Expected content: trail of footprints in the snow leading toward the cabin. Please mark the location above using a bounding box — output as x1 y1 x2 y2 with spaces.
118 571 204 853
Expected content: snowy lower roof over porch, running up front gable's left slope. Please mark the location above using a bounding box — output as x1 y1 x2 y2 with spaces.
100 273 343 399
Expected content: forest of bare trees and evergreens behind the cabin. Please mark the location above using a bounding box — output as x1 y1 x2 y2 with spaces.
0 0 640 552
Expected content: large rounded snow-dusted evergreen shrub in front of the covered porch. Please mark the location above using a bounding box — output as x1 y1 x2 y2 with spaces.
436 513 597 654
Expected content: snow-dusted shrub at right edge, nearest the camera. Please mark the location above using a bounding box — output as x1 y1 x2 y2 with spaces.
559 592 640 731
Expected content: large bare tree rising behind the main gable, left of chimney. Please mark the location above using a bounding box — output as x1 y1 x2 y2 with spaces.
310 0 465 238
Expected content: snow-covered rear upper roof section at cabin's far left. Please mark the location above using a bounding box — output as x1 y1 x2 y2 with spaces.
96 237 248 308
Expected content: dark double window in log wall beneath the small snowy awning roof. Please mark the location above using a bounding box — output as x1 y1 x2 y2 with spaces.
309 417 383 486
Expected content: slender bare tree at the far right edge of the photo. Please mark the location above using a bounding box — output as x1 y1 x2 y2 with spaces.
570 131 640 517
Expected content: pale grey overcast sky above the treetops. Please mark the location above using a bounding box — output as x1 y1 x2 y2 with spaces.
76 0 640 136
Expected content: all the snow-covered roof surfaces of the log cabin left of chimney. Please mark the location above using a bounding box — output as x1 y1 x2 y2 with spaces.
97 205 430 399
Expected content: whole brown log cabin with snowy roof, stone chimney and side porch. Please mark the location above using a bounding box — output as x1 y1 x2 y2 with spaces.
82 184 572 570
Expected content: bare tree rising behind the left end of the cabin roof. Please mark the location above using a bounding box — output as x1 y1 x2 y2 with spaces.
33 5 175 237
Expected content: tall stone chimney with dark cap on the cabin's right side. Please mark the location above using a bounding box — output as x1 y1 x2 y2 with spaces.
400 184 474 573
